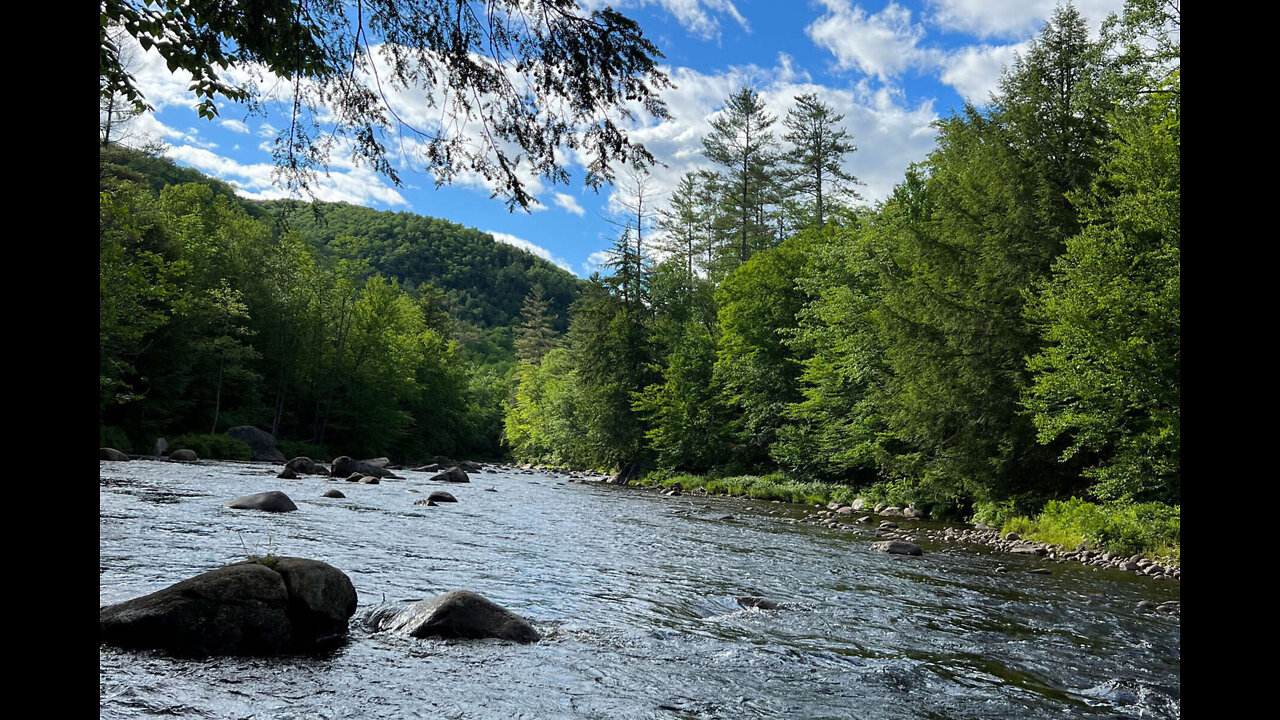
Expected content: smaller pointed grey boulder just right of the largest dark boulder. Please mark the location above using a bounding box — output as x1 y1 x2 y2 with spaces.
369 591 541 643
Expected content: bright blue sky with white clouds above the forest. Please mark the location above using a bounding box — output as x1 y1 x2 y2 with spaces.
115 0 1123 277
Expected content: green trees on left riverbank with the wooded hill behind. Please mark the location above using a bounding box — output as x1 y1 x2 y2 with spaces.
99 146 577 459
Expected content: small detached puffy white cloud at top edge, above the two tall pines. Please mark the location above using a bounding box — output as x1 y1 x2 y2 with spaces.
805 0 937 82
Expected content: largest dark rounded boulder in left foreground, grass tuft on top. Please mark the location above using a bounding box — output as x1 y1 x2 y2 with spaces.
99 556 356 656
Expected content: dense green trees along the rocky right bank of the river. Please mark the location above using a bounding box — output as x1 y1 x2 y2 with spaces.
508 0 1180 532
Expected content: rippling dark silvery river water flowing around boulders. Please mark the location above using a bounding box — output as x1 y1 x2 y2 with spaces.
99 460 1181 720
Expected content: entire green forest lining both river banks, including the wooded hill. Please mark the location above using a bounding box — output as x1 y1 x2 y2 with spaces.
100 3 1180 544
